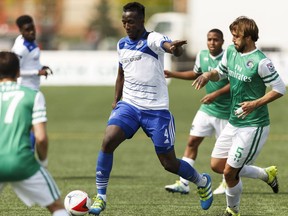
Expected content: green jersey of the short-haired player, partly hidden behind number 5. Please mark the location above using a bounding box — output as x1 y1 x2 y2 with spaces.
194 50 231 119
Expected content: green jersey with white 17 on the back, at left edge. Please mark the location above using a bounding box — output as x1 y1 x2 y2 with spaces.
0 82 47 182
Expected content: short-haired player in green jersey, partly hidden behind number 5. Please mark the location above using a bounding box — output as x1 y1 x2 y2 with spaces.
164 29 230 194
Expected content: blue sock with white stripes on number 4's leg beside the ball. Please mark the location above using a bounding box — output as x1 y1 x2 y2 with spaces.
96 150 113 195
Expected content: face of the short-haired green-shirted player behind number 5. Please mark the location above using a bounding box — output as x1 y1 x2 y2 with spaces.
207 32 224 56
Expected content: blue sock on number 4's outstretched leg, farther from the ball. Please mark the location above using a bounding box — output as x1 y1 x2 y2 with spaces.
177 159 201 184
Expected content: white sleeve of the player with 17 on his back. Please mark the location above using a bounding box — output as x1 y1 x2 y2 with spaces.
32 91 47 125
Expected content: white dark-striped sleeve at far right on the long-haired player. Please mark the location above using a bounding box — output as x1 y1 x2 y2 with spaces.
258 58 286 95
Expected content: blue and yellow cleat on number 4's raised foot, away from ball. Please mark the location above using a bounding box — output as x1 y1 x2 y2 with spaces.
198 173 213 210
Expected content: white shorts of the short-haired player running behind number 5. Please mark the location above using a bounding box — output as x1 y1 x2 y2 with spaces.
190 110 228 139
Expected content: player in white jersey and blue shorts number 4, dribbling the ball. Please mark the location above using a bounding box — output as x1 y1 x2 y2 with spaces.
89 2 213 215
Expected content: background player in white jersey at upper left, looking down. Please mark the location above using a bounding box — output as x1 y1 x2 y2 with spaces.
12 15 52 90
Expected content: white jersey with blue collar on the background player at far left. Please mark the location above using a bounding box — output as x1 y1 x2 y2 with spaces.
12 35 42 90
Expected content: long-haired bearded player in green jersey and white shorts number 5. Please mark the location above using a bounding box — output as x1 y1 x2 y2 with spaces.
192 16 286 216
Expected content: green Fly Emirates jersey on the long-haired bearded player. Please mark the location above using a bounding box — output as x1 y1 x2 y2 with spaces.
217 45 280 127
